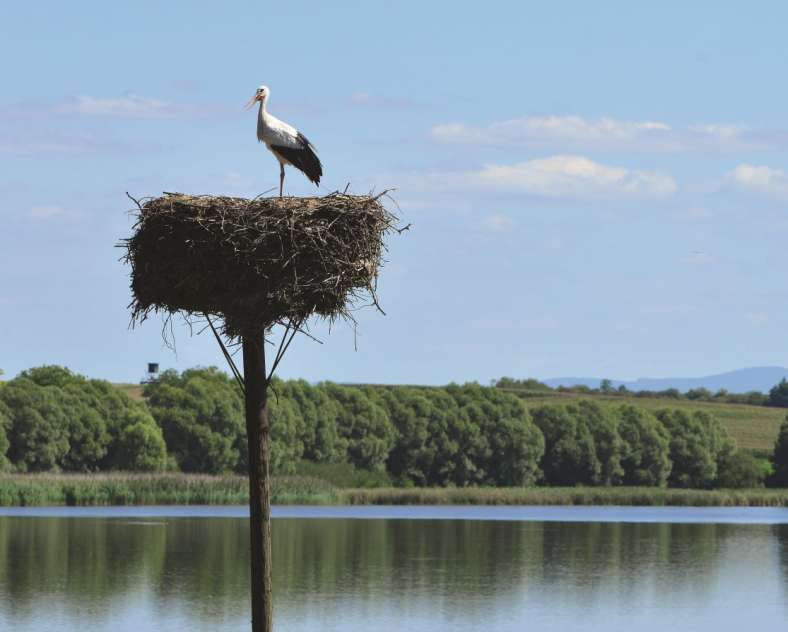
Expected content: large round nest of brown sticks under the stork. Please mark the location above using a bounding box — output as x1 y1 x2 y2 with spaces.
122 193 396 337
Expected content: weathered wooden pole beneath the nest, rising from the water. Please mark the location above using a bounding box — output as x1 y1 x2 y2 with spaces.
242 329 273 632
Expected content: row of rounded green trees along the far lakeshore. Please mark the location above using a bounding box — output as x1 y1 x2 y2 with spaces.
0 366 788 488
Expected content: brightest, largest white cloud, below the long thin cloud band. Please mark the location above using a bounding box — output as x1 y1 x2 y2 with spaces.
468 156 678 199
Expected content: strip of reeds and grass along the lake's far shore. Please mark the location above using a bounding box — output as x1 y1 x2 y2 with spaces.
0 473 788 507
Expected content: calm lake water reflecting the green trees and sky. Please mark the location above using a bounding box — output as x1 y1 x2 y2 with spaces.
0 507 788 632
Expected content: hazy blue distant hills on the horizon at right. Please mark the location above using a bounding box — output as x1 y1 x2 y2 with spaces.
542 366 788 393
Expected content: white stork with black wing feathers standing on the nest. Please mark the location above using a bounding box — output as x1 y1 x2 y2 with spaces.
247 86 323 197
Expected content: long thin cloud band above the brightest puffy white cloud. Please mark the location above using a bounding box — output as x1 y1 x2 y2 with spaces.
431 116 788 152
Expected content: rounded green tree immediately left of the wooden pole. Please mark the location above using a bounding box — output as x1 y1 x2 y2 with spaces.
144 368 246 473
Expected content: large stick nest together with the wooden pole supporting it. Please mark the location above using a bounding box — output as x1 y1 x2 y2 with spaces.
121 193 396 632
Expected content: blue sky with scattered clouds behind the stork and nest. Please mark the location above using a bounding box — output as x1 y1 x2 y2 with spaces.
0 0 788 383
